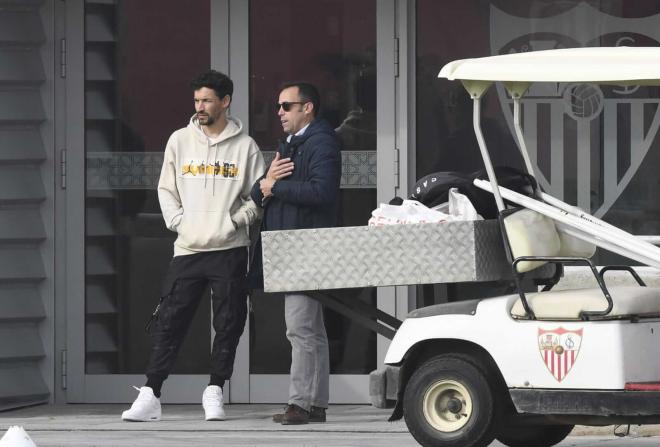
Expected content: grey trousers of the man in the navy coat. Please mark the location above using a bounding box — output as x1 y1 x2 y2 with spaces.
284 295 330 411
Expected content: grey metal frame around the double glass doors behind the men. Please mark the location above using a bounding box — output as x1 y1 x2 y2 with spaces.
61 0 414 403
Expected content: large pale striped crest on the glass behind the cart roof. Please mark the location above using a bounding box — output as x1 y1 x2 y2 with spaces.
490 2 660 218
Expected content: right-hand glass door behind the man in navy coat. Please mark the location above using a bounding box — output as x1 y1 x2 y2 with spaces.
237 0 394 403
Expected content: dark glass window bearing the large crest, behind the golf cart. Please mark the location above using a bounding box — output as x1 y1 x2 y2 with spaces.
416 0 660 304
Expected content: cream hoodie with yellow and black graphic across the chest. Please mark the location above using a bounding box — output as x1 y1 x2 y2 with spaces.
158 116 265 256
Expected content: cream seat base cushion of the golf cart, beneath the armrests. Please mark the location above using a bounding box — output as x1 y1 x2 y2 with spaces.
511 286 660 320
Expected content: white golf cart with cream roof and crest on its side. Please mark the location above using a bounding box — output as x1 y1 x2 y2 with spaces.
385 47 660 447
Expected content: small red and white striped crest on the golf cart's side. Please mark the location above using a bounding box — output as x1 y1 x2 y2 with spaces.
538 327 583 382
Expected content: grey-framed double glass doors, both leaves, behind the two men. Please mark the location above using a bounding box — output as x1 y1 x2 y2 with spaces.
62 0 400 403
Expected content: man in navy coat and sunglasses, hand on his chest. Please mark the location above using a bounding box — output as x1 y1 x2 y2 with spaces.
251 82 341 425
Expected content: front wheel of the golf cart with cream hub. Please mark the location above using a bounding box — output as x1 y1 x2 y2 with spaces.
403 355 494 447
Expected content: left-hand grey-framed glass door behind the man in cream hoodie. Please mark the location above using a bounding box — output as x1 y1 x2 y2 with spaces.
66 0 223 402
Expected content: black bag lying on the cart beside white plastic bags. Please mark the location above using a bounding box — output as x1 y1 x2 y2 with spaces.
410 166 536 219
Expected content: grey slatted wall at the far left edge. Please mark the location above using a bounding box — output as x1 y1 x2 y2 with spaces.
0 0 52 410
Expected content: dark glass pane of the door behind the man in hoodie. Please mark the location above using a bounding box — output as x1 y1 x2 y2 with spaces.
85 0 211 374
